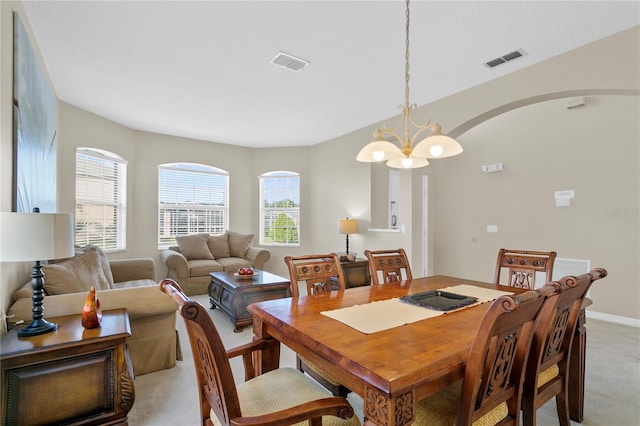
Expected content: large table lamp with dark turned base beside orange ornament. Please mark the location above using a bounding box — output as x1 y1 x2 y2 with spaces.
0 209 74 337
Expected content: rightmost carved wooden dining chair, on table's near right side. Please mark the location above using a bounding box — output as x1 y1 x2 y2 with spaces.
522 268 607 426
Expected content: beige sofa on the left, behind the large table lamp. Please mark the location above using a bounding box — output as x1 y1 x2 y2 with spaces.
7 247 182 375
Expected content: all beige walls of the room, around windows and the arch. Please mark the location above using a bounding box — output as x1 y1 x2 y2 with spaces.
0 2 640 330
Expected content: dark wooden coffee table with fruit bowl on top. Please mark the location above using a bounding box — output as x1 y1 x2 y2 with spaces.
208 269 291 333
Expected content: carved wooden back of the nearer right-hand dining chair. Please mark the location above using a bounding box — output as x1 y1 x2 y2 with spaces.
457 291 547 425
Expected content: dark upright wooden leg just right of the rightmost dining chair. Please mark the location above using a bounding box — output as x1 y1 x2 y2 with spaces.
567 309 587 423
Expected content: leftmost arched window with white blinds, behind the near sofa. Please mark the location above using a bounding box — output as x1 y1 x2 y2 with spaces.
75 147 127 253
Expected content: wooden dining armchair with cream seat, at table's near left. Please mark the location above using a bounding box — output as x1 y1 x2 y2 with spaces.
160 278 360 426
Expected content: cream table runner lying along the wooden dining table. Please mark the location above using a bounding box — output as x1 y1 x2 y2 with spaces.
321 284 513 334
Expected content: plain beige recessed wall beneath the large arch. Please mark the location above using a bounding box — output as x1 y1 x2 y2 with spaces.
432 96 640 318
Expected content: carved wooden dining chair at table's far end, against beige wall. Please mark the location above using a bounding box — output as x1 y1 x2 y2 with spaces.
493 248 556 290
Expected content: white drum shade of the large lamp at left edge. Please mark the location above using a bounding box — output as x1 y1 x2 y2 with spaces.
0 212 74 262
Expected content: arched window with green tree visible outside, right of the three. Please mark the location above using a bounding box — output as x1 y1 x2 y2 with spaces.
260 171 300 246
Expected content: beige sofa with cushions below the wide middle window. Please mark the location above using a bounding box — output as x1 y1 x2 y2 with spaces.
160 231 271 296
